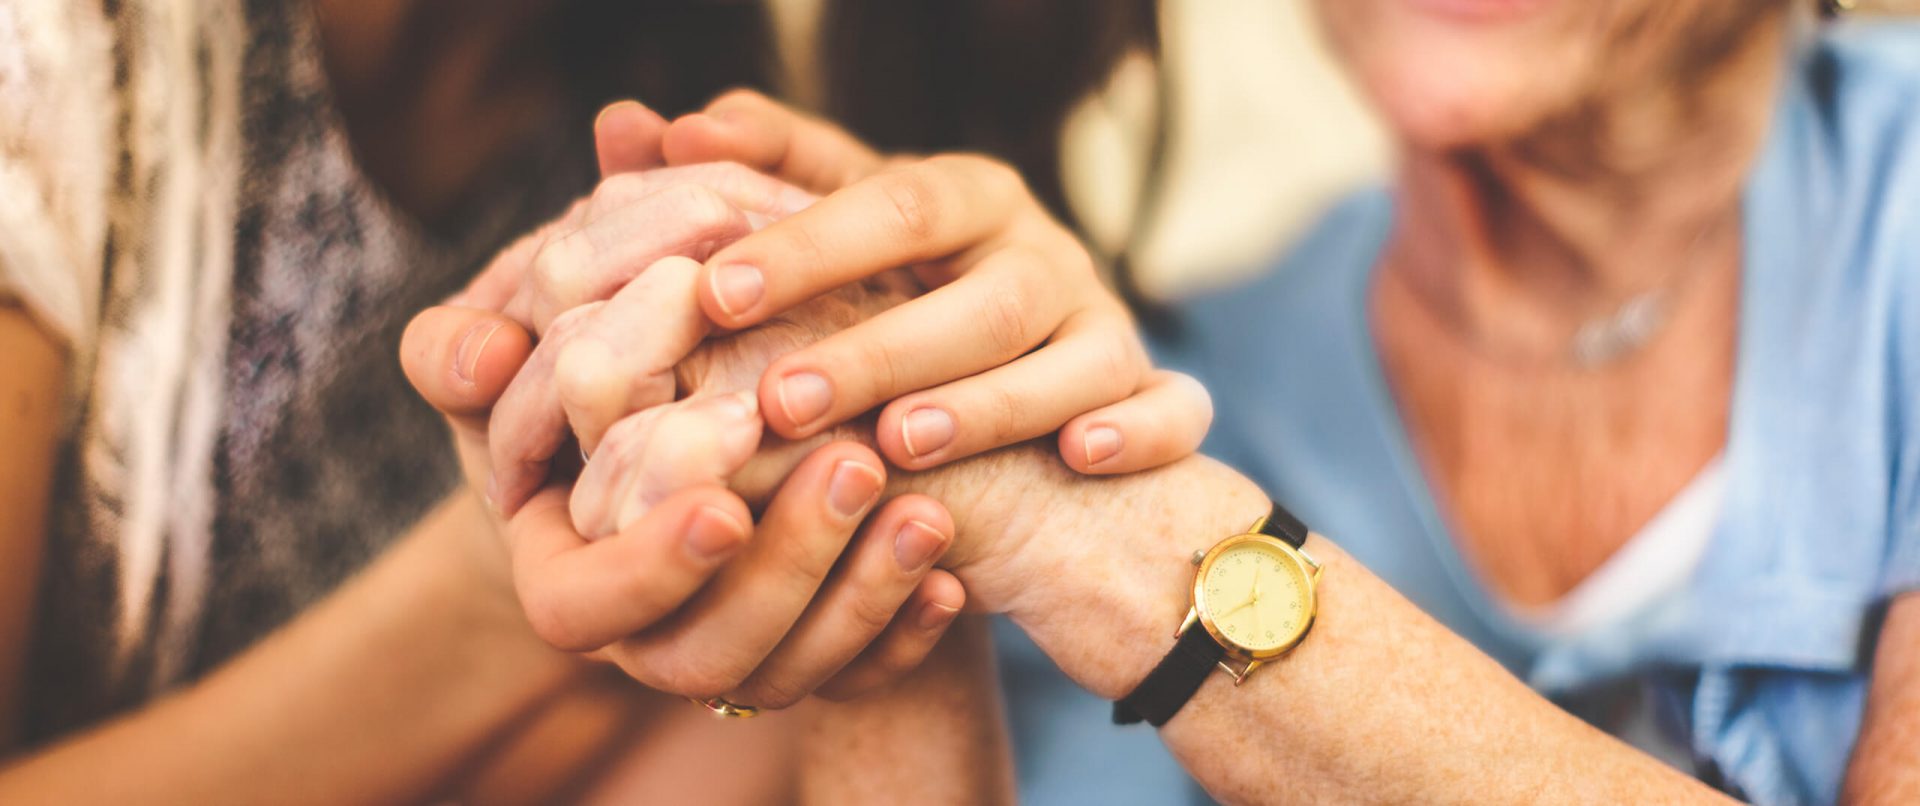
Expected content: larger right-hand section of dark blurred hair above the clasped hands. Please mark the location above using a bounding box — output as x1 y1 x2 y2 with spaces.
820 0 1169 314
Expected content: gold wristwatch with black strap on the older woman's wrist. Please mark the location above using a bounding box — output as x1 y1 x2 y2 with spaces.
1114 503 1321 727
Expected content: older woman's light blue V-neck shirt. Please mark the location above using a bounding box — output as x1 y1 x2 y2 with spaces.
1002 25 1920 804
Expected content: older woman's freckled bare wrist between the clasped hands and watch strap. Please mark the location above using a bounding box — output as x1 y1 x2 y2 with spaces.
935 452 1269 699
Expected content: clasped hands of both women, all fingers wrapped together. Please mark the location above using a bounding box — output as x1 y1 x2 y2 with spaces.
401 92 1212 708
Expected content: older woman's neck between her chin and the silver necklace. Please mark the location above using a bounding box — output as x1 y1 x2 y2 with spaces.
1392 19 1786 313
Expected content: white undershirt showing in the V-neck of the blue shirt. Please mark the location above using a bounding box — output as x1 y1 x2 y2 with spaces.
1513 457 1726 635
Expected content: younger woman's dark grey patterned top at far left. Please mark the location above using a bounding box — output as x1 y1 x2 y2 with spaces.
18 0 593 739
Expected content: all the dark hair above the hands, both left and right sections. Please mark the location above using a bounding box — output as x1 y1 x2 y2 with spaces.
555 0 1169 310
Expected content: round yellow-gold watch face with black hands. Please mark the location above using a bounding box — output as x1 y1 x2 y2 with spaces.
1194 539 1313 654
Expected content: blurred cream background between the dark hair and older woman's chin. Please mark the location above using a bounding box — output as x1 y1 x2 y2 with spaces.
768 0 1388 297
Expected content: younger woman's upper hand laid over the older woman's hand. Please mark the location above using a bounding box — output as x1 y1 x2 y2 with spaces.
660 92 1212 474
